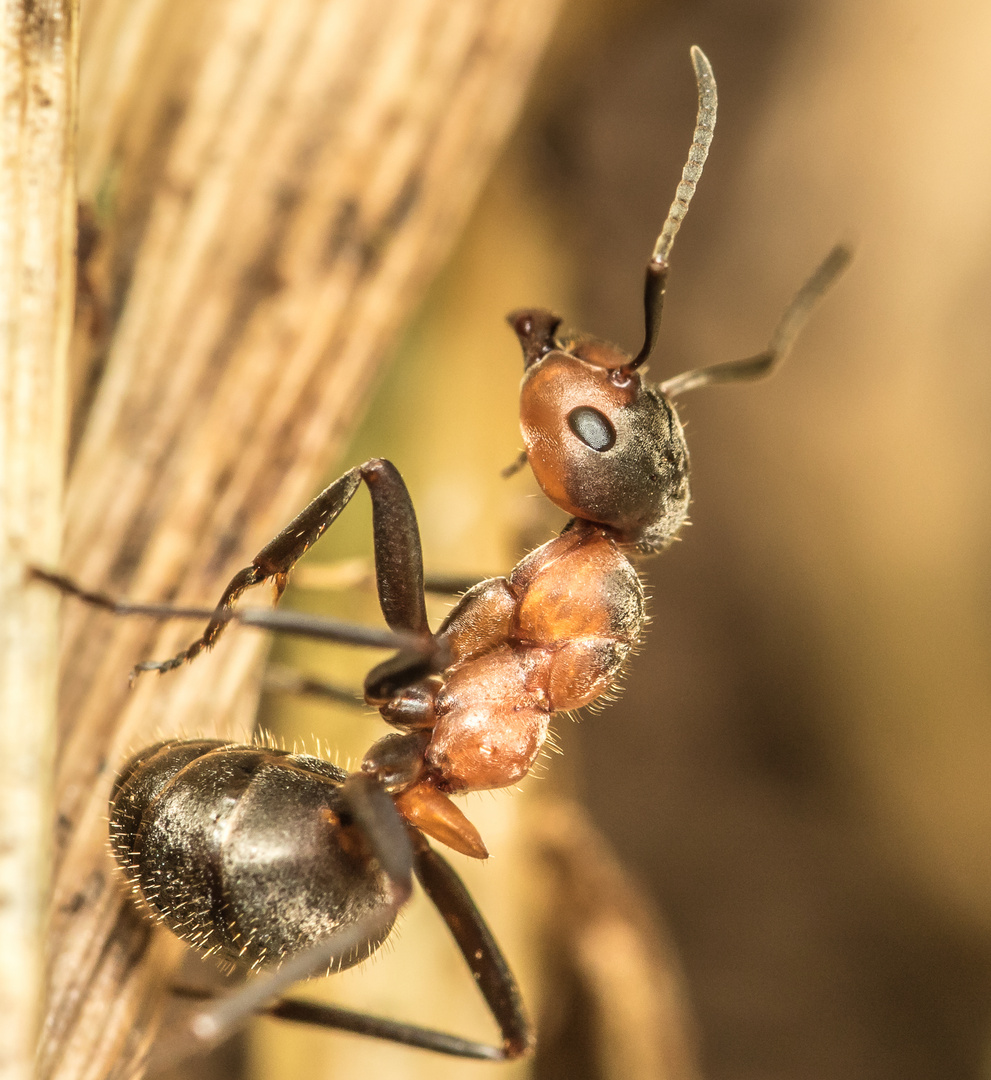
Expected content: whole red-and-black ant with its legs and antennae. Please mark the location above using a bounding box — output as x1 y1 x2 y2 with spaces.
37 49 850 1061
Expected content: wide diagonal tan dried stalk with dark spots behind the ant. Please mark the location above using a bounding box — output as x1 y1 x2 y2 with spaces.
41 0 556 1080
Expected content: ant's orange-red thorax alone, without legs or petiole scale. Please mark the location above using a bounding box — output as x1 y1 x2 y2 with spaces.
425 523 644 777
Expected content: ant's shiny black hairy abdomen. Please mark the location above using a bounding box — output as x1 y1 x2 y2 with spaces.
110 740 391 968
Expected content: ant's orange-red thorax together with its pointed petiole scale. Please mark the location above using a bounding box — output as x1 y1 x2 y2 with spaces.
363 521 646 855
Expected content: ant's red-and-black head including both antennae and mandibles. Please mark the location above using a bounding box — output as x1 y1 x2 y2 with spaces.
508 46 850 551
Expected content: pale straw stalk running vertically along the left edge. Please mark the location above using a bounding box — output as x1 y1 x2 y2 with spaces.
0 0 77 1080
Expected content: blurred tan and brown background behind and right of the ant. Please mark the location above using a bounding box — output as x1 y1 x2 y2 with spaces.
60 0 991 1080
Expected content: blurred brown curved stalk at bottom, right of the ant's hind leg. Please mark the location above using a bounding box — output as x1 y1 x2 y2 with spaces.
526 798 702 1080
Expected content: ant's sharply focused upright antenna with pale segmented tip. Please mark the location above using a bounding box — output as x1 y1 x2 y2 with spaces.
623 45 716 373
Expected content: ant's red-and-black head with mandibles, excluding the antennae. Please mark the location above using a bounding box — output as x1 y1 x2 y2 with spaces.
508 310 689 551
